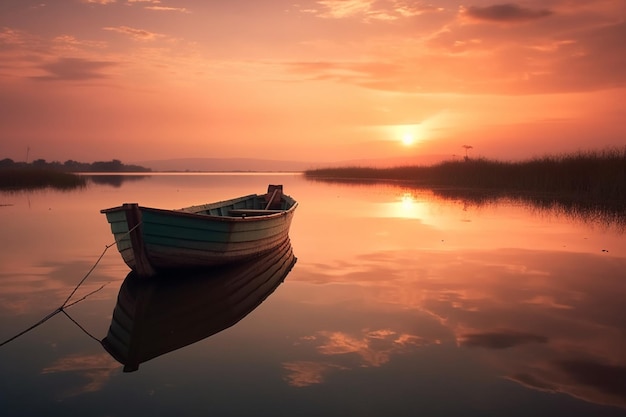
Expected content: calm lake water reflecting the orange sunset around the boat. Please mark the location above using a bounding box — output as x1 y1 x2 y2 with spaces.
0 174 626 417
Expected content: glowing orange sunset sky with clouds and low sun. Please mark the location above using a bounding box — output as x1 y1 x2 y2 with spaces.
0 0 626 162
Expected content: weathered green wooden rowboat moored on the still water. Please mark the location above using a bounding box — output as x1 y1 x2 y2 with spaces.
101 185 298 277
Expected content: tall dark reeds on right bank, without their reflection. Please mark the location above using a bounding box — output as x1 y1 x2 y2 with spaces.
305 147 626 201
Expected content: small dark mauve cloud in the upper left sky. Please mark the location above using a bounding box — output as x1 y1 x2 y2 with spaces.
33 58 115 81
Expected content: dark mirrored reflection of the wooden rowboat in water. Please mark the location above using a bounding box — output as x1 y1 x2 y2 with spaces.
102 239 296 372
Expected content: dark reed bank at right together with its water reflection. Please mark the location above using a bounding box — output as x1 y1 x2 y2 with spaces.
305 147 626 230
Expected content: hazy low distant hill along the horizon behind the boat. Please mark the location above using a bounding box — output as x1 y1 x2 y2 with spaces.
133 155 450 172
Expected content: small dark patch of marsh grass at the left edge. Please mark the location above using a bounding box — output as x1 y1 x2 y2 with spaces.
0 167 86 191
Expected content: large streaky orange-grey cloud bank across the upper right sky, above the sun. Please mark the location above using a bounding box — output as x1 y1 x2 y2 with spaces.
284 14 626 95
